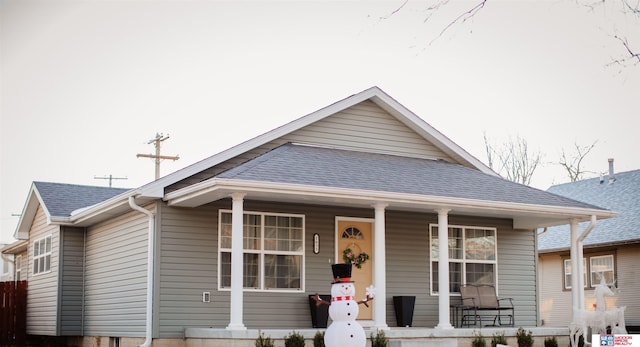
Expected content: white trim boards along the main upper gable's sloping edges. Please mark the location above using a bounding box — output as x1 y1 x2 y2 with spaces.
140 87 497 198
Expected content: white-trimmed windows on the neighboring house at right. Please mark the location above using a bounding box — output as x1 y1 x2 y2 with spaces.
563 254 615 290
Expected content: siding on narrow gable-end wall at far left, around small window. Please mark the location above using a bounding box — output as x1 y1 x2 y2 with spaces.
23 207 60 335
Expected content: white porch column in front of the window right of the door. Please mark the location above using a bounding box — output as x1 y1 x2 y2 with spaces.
438 208 453 329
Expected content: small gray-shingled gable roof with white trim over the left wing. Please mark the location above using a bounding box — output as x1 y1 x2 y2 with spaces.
15 182 129 239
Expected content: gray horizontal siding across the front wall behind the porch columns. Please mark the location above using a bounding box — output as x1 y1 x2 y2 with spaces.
159 200 537 338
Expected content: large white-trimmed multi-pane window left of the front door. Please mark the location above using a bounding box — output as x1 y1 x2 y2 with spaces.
218 211 304 291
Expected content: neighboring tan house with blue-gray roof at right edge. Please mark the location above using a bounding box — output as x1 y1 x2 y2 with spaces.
538 163 640 332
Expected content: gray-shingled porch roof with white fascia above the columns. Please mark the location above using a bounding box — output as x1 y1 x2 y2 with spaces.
165 144 613 229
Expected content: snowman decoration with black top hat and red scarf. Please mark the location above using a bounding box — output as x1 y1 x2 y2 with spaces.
315 264 374 347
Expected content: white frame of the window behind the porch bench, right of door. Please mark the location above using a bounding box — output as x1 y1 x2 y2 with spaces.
429 224 498 296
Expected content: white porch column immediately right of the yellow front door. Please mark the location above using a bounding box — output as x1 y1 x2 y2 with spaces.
373 203 389 329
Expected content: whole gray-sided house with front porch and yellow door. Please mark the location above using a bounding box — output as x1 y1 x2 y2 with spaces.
6 87 615 345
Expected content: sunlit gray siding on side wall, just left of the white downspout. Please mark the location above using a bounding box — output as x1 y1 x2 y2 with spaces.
84 207 149 337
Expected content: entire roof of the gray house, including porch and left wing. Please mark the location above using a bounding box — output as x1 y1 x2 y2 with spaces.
16 87 615 234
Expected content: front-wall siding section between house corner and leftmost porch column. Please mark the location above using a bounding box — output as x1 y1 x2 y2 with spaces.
157 206 220 337
